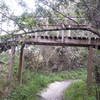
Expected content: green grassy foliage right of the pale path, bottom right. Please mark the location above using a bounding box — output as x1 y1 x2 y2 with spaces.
64 80 96 100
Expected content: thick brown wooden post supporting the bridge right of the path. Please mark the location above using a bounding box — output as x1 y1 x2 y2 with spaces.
87 46 94 84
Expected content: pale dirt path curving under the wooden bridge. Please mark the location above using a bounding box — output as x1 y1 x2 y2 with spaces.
40 80 73 100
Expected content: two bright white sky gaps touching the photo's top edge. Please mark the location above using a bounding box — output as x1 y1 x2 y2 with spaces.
4 0 35 16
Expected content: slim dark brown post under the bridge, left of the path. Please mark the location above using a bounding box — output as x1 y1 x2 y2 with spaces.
18 44 25 85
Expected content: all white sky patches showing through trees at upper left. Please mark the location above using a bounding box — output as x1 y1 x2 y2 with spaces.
0 0 36 35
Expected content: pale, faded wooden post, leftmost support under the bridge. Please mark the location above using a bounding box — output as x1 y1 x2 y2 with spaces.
8 46 15 81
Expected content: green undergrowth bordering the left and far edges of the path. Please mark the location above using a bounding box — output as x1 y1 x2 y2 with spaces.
3 68 87 100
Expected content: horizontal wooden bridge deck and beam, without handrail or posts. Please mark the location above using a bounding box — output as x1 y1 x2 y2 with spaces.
0 35 100 52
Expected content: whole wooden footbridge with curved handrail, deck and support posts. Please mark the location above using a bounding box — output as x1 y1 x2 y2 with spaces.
0 25 100 83
